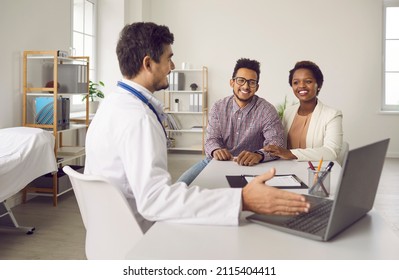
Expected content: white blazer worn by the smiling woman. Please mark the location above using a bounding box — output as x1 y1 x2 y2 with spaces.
283 100 343 161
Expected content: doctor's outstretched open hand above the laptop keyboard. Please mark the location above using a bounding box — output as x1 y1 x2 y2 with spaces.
242 168 310 215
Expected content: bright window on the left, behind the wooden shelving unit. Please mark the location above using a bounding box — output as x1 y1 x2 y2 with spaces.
71 0 97 111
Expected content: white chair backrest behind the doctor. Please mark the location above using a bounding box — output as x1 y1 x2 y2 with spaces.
63 166 143 260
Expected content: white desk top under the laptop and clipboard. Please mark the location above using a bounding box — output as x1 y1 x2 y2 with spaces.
129 161 399 260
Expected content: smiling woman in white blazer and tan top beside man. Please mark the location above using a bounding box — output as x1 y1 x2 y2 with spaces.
264 61 343 161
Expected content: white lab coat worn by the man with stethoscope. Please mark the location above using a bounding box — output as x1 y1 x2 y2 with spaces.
85 80 241 232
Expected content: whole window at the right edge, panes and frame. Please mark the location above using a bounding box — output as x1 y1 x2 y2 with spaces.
382 0 399 111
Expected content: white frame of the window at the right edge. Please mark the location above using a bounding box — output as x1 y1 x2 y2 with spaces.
381 0 399 113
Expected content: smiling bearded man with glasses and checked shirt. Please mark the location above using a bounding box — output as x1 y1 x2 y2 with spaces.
178 58 285 185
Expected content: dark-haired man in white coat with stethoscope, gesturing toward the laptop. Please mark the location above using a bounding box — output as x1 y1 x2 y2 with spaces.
85 22 309 232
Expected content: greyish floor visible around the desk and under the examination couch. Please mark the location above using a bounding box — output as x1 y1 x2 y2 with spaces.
0 154 399 260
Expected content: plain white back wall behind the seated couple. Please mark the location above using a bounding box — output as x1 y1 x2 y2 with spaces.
133 0 399 157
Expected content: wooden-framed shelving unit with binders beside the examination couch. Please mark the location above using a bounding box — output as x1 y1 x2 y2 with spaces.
22 50 89 206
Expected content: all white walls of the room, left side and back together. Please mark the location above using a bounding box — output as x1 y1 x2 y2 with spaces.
0 0 399 157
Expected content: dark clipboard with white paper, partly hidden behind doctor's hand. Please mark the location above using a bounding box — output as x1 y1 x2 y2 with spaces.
226 174 308 189
